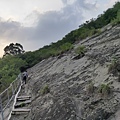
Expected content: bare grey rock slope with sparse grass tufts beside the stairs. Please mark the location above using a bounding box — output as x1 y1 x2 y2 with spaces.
12 25 120 120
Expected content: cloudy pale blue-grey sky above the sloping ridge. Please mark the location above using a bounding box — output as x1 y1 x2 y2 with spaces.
0 0 119 57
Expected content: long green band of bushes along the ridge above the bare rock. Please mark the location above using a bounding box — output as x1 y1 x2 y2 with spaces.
19 2 120 67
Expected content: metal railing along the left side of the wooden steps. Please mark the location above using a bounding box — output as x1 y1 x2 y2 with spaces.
0 74 22 120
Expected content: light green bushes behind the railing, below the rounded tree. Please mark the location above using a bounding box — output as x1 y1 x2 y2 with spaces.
0 56 27 86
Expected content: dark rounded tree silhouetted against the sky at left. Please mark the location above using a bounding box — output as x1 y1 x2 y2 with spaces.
3 43 25 56
